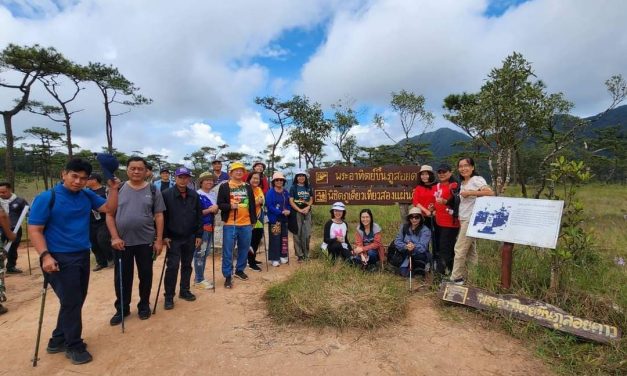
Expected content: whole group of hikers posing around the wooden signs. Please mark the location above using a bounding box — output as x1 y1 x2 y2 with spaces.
0 153 492 364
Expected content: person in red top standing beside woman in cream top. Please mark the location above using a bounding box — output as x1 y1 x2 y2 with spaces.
434 163 459 274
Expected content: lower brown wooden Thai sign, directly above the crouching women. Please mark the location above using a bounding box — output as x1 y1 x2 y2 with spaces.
313 187 413 205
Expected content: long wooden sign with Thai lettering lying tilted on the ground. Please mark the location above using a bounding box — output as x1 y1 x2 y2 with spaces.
438 283 621 343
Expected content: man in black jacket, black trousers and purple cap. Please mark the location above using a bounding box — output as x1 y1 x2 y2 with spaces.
163 167 203 309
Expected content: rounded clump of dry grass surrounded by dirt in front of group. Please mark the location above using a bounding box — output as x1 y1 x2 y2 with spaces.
265 260 408 329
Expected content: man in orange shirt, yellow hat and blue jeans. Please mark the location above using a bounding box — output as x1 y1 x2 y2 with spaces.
217 162 257 288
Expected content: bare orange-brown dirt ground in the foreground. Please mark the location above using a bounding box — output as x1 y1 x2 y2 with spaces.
0 244 550 376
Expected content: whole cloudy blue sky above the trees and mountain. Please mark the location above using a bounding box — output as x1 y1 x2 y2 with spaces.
0 0 627 168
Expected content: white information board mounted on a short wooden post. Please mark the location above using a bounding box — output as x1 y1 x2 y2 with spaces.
466 196 564 248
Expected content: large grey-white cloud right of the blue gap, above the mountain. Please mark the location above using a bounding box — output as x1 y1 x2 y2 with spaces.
296 0 627 114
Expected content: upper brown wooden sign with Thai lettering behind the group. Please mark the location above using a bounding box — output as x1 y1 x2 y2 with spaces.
309 166 420 188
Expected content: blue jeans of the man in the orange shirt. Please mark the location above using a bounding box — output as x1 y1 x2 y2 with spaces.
222 225 253 278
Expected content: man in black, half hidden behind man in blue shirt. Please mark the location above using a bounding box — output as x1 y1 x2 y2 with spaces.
87 174 113 272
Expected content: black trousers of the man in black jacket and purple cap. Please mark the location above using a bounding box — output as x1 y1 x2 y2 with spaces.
163 235 196 298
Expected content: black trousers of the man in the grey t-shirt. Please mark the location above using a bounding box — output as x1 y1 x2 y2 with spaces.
113 244 153 312
